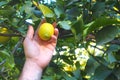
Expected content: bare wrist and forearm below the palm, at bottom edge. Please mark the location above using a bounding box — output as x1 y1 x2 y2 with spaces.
19 60 42 80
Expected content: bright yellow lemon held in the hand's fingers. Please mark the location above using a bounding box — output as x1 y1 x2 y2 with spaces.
38 23 54 41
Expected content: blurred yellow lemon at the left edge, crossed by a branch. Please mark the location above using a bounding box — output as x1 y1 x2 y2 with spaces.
0 27 10 44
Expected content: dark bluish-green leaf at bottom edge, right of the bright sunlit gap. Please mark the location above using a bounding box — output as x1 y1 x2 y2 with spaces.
93 65 112 80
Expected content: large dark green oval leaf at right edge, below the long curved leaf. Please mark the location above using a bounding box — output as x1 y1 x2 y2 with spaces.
96 26 119 45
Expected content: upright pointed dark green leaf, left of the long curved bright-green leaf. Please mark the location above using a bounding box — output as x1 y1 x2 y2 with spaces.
71 16 84 41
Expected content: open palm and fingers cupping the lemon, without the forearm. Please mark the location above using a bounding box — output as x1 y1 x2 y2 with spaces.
23 20 58 69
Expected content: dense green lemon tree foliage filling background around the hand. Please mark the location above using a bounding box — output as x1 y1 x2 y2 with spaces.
0 0 120 80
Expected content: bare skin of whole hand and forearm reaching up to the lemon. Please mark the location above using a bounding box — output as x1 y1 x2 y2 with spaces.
19 20 59 80
